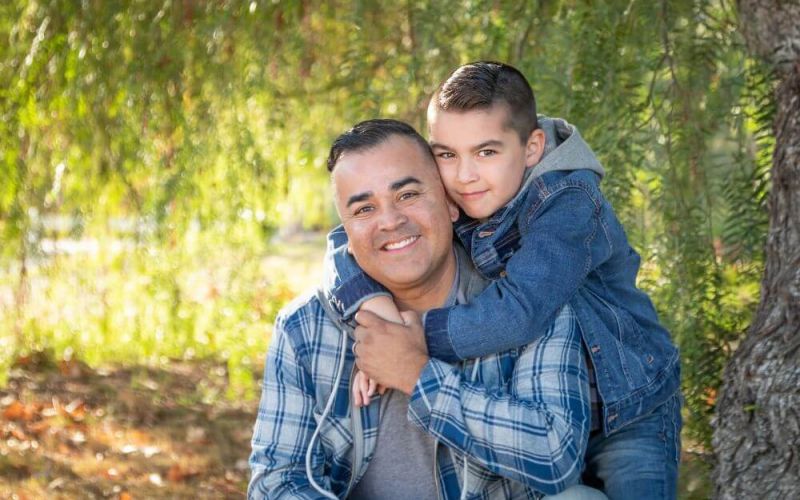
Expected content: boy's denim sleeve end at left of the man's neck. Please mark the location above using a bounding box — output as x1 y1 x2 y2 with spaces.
322 225 390 320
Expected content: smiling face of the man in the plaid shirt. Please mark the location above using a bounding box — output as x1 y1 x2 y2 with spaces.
333 135 458 294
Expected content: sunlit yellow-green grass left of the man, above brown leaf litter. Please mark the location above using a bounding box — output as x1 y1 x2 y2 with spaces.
0 230 324 398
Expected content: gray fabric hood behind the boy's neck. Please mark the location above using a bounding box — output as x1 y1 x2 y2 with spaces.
523 115 605 189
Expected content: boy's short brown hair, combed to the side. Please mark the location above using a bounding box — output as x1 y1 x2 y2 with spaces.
431 61 539 144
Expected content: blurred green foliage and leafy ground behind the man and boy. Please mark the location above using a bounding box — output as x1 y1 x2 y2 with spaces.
0 0 774 498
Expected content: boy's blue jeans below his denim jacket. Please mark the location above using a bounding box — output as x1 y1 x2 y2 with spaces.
583 392 682 500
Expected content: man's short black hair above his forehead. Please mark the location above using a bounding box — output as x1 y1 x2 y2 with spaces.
328 118 435 172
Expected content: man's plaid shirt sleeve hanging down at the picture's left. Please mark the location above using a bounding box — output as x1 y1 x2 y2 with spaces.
247 311 329 499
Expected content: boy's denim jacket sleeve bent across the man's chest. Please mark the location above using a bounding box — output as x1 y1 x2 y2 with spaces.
424 181 612 361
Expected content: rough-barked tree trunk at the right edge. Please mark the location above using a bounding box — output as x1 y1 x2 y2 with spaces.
713 0 800 499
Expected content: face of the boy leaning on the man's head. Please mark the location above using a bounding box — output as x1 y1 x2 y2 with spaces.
428 104 544 219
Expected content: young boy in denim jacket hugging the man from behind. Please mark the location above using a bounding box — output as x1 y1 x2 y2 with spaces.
326 62 681 499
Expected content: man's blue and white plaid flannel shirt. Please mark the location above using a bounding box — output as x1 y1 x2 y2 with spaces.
248 259 591 499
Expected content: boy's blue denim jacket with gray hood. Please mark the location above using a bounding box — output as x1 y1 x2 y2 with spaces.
325 119 680 433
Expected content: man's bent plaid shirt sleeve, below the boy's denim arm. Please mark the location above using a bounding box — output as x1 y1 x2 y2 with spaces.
409 306 591 495
